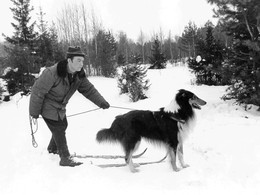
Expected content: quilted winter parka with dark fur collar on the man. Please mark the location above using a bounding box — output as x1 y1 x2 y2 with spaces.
29 60 106 121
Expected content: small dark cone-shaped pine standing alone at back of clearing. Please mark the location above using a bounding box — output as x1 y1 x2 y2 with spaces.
149 36 167 69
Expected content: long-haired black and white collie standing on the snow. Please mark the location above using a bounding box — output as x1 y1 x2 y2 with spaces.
96 89 206 172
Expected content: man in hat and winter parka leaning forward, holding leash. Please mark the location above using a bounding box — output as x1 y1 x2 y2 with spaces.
29 47 110 167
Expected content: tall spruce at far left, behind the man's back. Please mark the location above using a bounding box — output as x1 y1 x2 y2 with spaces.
4 0 37 94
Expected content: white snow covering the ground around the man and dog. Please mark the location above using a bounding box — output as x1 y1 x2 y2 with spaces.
0 66 260 195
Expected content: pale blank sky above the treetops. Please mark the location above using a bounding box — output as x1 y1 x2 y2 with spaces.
0 0 217 41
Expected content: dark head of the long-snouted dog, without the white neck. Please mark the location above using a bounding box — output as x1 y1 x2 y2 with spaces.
175 89 207 109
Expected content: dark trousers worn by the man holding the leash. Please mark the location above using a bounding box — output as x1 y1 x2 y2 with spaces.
43 117 70 157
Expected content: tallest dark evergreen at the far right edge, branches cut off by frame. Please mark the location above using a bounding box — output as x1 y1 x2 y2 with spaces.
208 0 260 106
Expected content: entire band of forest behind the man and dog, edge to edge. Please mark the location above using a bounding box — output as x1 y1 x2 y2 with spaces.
0 0 260 106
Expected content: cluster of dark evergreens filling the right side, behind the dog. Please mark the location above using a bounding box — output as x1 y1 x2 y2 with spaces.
188 0 260 106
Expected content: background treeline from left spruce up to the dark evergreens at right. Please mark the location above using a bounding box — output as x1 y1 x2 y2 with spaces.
1 0 223 76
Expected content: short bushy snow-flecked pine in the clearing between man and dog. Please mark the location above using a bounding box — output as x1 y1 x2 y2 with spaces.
117 64 149 102
